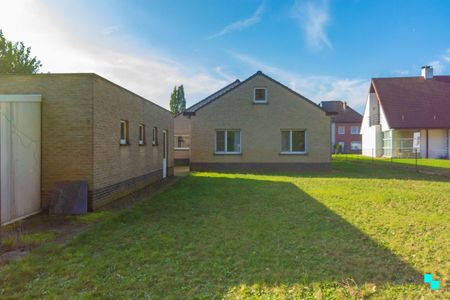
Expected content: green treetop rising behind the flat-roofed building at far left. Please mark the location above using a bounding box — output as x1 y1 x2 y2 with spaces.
0 30 42 74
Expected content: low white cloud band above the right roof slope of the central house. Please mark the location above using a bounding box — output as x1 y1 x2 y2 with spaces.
231 52 370 112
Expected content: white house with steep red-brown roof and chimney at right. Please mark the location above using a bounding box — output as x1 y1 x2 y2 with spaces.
361 66 450 158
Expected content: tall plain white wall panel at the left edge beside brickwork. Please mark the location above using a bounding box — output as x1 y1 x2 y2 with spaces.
0 95 41 224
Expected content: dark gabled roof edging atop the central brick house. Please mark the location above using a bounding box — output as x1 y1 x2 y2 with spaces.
183 71 325 115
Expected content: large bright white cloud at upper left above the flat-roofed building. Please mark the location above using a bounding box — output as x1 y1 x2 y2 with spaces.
0 0 228 108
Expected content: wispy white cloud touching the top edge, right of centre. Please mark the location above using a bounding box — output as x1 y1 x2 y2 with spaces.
292 0 332 49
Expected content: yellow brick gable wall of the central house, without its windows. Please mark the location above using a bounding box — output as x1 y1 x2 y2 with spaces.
190 75 331 163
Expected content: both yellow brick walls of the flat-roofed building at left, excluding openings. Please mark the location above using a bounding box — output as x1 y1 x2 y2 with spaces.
0 74 173 208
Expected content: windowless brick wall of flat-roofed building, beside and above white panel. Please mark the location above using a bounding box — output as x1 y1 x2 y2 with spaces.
0 74 93 207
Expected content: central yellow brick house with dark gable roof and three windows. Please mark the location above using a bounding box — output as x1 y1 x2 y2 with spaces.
175 71 331 172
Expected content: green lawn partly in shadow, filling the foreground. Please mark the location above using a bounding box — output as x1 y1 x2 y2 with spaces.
0 160 450 299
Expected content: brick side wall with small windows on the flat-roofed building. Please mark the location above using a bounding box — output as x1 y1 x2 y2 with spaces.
93 77 173 189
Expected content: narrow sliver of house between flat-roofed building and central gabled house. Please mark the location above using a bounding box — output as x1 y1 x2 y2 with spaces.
173 113 191 166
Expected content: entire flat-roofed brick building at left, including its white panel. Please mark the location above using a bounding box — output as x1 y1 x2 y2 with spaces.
0 74 173 223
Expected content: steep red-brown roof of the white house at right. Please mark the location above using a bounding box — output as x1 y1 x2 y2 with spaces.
370 76 450 129
